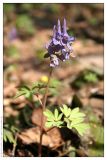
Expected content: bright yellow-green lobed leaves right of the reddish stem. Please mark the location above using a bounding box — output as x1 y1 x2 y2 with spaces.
44 104 89 136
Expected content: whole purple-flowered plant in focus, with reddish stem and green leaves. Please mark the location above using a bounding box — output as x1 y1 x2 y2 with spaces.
14 19 88 157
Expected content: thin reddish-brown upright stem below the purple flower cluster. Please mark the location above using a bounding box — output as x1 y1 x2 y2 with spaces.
38 68 53 157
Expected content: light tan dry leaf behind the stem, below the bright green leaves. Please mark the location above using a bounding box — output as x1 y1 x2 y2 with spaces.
18 127 62 148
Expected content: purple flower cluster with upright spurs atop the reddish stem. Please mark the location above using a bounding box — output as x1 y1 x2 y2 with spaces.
45 19 75 67
